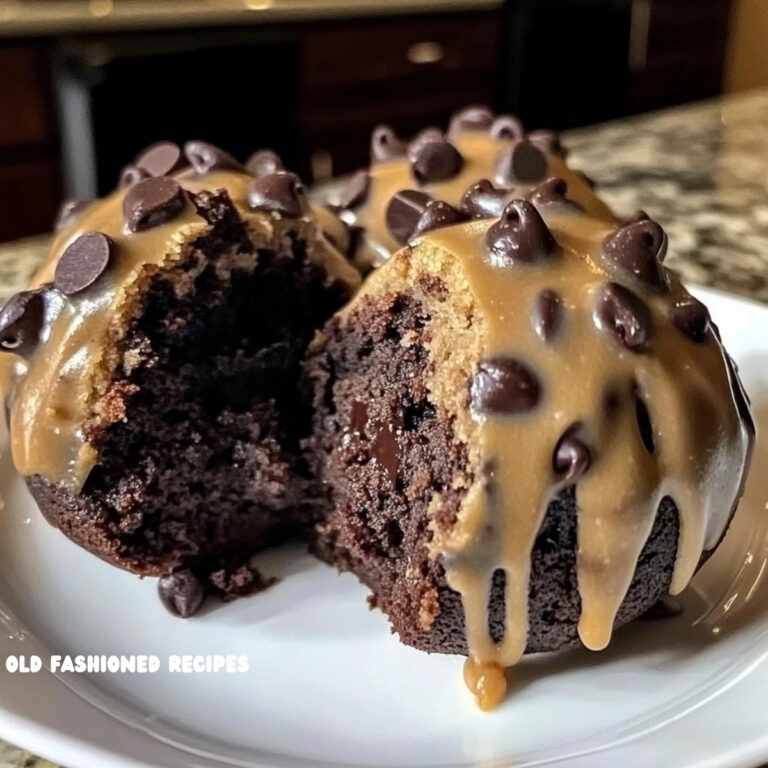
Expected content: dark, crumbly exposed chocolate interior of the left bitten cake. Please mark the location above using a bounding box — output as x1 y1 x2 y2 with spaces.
34 194 345 597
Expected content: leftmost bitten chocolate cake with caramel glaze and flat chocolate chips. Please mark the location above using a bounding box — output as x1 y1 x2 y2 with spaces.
0 142 360 616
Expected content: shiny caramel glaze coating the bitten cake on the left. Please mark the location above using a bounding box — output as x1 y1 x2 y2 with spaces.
0 168 360 492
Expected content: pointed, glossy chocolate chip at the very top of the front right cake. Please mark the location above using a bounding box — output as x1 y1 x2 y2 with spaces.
485 200 557 266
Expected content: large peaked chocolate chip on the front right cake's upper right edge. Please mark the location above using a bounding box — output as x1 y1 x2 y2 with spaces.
602 221 667 291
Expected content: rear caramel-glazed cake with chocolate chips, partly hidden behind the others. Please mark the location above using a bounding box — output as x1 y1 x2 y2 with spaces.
333 106 616 271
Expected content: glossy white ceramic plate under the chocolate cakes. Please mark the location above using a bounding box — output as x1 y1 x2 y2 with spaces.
0 290 768 768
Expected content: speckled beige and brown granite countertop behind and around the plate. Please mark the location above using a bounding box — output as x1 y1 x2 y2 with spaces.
0 91 768 768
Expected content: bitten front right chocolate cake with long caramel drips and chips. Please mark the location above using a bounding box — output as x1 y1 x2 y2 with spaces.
308 195 754 708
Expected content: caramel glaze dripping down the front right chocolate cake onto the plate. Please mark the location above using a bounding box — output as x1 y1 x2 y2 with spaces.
358 203 754 709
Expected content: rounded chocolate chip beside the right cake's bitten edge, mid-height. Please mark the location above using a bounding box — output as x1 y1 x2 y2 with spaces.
470 357 541 416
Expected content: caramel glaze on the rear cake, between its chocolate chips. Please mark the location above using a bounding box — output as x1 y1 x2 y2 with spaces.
342 130 616 270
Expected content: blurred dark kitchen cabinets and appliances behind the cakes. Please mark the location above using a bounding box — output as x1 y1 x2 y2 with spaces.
0 0 768 241
